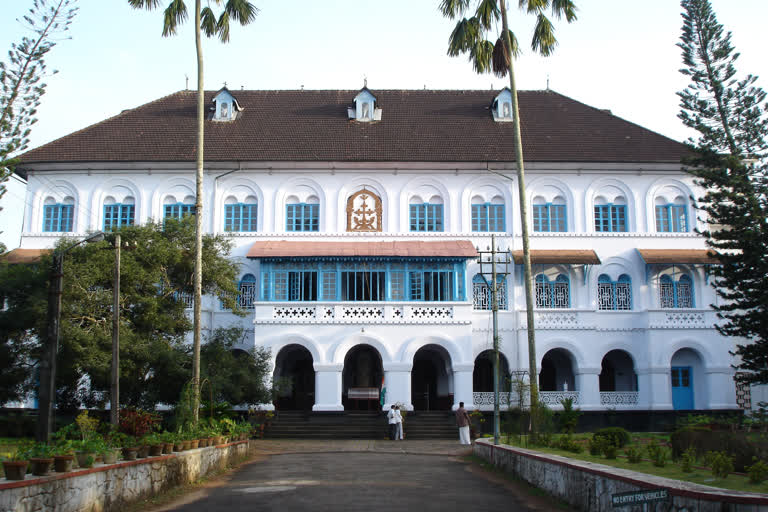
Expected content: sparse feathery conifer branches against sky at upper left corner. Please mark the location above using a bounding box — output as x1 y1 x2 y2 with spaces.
0 0 78 207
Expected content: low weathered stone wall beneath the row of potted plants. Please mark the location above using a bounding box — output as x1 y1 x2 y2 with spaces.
0 441 249 512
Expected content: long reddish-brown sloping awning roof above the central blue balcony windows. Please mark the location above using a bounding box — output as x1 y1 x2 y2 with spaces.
246 240 477 258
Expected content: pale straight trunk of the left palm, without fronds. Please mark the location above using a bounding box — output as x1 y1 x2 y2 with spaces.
192 0 205 423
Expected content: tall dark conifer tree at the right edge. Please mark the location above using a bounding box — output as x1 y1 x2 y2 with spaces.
678 0 768 383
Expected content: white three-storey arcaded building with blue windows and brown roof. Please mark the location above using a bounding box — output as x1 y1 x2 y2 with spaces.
13 88 738 411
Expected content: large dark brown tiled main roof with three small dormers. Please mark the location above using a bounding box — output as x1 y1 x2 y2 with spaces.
21 90 686 165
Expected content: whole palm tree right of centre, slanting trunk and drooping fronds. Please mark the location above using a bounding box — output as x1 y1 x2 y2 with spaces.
440 0 576 426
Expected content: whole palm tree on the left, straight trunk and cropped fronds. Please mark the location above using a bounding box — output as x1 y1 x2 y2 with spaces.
128 0 259 422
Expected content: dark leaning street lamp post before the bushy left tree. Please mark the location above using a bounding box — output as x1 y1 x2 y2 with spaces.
35 231 104 443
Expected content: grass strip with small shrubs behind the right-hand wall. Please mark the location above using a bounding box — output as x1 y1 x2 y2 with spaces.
502 433 768 493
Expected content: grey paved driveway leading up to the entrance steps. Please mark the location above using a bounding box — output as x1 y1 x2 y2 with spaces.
158 441 557 512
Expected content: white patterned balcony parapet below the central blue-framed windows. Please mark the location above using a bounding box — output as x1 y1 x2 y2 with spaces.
254 302 472 325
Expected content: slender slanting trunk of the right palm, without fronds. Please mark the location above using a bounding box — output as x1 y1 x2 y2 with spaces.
501 0 539 424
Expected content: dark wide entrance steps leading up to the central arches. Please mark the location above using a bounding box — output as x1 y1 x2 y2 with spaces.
264 411 458 439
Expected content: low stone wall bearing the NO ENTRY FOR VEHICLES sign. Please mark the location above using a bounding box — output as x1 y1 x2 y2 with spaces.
473 439 768 512
